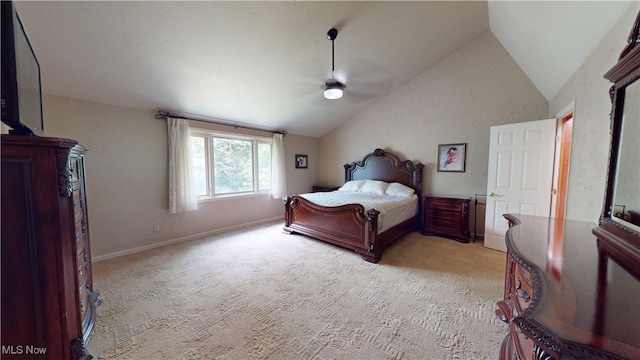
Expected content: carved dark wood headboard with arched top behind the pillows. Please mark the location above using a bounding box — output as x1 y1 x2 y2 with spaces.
344 149 424 198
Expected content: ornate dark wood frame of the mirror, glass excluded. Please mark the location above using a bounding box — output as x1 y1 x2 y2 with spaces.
593 12 640 278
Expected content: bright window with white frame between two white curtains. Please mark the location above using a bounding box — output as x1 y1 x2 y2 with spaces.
191 129 273 199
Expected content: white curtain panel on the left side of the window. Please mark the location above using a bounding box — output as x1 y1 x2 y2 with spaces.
167 118 198 214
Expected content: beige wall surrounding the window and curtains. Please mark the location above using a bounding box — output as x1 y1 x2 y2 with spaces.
43 95 318 259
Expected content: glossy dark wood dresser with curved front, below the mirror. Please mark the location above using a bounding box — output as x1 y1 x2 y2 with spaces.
496 214 640 359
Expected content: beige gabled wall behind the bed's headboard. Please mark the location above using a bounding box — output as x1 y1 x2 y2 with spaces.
319 32 548 202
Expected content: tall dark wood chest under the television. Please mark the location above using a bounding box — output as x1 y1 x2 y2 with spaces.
0 135 100 359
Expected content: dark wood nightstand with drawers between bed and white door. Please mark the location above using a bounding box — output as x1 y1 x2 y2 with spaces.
422 196 471 243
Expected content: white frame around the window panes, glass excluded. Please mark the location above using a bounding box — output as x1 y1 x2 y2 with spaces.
189 127 274 202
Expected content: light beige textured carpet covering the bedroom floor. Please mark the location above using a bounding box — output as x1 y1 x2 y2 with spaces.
89 223 508 360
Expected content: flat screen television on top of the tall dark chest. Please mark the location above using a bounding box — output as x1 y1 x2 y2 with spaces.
2 1 44 135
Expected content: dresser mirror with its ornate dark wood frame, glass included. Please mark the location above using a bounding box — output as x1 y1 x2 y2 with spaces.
593 12 640 279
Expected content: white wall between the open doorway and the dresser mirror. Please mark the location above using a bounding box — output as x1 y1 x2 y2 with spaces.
548 2 640 222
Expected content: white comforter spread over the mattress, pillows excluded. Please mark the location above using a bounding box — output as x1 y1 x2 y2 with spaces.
300 191 418 233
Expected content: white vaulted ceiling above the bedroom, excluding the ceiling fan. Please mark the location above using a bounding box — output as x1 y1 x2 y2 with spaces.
16 1 631 137
